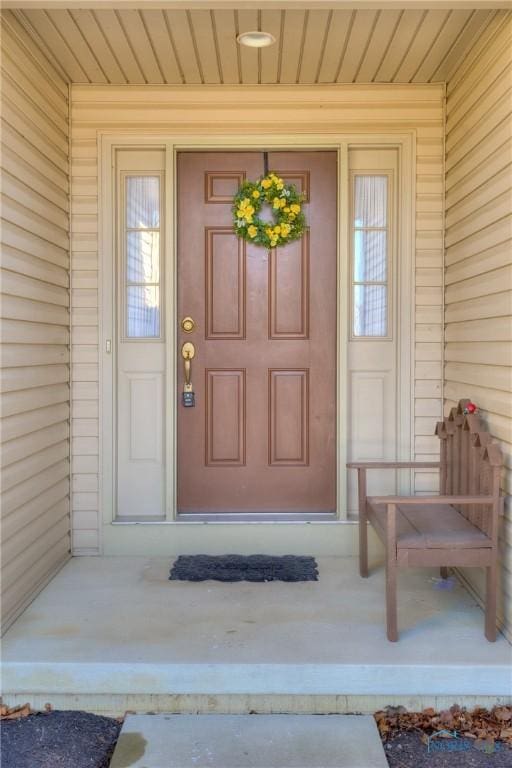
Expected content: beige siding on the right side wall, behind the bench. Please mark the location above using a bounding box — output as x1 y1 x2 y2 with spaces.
444 13 512 633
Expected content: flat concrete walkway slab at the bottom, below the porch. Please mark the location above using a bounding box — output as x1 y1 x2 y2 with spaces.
110 715 388 768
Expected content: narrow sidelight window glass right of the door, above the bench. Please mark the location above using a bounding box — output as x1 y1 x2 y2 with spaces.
352 174 390 338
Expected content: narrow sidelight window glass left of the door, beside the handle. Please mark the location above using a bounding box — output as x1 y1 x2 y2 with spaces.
123 175 162 339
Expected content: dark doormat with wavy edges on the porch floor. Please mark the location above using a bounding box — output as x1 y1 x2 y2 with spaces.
169 555 318 581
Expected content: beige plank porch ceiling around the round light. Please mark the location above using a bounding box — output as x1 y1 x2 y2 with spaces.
6 8 497 84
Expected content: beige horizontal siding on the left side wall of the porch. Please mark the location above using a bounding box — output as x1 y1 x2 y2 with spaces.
1 14 70 629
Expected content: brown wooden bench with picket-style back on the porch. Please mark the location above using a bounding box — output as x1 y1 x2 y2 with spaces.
347 400 503 642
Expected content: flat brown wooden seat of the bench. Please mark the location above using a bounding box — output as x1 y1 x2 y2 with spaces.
367 496 492 550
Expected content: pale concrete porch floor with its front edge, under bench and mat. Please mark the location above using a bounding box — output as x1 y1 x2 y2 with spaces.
2 557 512 713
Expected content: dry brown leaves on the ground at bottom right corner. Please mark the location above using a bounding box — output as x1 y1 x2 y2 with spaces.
374 704 512 747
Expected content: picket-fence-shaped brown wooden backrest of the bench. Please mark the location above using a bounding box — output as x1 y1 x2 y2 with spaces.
436 400 503 536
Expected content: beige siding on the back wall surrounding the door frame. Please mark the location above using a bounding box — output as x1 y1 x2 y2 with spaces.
71 85 444 554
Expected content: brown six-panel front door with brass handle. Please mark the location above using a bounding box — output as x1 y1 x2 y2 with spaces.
178 152 337 513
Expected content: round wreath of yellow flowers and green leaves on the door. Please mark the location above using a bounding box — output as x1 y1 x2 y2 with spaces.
232 172 306 248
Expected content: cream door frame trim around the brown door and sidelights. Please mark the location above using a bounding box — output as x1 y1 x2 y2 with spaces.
98 127 416 526
